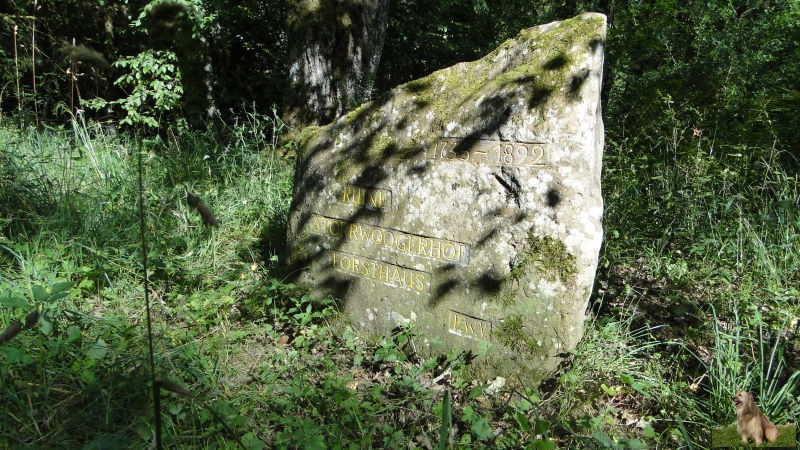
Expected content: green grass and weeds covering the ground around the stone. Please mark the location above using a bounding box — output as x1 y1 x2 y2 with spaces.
0 106 800 449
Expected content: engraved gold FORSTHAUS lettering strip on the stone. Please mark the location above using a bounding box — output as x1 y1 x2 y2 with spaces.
330 250 431 292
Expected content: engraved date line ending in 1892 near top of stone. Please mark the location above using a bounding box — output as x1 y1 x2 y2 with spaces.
426 137 545 167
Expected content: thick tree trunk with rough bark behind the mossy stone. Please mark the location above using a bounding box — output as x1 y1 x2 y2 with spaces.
285 0 389 126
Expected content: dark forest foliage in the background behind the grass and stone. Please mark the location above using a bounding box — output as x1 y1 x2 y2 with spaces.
0 0 800 165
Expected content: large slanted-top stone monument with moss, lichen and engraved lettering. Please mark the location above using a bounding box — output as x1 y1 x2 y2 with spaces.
289 14 606 383
